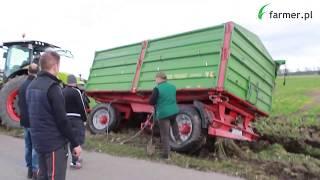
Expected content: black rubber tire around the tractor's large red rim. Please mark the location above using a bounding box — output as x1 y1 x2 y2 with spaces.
0 75 27 128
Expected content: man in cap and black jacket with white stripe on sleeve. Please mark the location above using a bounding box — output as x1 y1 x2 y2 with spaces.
62 75 87 169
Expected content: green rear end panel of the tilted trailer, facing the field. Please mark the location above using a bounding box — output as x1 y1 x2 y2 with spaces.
224 25 275 113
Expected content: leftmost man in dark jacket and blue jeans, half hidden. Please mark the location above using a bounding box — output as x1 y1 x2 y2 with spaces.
18 64 38 179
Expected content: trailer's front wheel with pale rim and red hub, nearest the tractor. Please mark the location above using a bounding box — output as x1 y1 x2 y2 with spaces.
88 104 120 134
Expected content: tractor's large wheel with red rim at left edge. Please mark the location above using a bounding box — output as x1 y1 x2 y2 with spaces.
0 76 27 128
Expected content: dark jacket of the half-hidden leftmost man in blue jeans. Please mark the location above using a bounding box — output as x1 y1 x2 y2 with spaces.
18 75 35 128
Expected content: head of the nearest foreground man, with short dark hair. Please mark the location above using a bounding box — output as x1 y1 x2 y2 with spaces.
40 50 60 70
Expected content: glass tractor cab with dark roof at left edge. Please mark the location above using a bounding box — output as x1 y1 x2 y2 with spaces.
1 41 59 82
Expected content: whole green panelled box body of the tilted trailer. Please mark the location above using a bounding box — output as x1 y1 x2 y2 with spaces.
86 24 275 113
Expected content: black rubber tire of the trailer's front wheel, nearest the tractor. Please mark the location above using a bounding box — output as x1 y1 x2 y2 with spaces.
88 104 121 134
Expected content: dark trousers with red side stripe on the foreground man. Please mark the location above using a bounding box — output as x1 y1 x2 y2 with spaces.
38 144 68 180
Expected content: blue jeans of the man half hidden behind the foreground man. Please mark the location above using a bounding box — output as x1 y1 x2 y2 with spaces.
24 128 38 172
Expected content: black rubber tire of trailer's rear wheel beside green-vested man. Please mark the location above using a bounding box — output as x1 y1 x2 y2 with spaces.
170 105 204 153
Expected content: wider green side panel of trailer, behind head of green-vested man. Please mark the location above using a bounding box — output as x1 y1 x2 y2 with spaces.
138 25 224 90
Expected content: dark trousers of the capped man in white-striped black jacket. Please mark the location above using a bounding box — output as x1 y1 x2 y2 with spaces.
68 116 86 164
